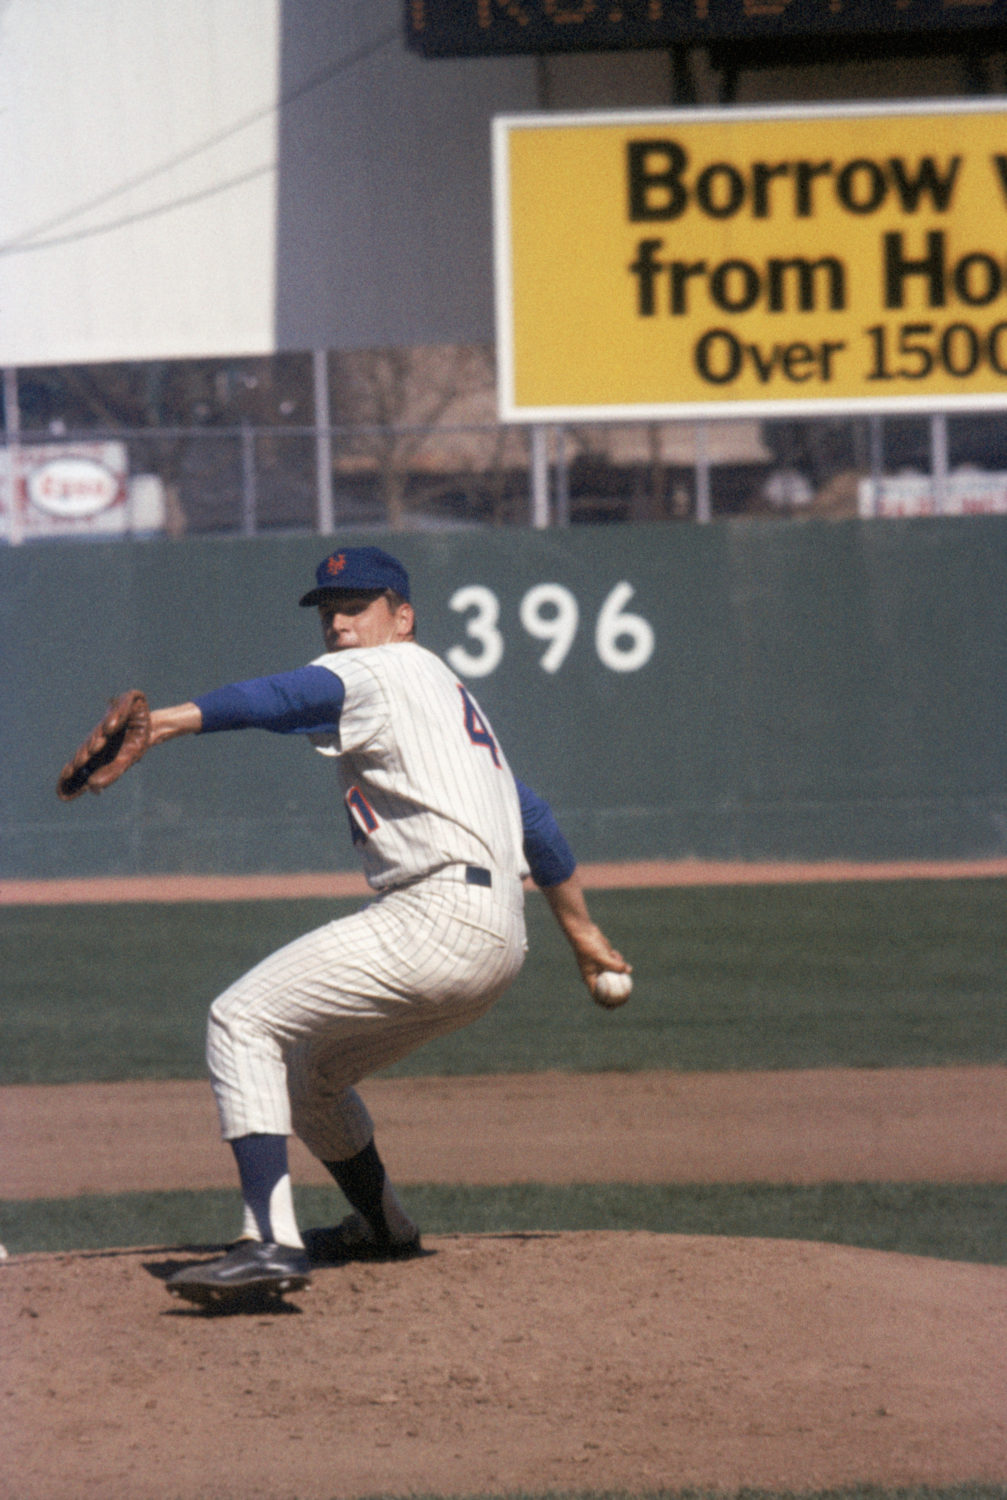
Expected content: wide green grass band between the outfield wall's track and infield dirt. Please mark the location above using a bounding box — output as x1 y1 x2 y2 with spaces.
0 879 1007 1083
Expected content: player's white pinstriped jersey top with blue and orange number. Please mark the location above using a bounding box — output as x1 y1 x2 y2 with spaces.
311 641 527 890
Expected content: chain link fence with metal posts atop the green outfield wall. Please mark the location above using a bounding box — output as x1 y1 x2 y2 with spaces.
0 414 1007 542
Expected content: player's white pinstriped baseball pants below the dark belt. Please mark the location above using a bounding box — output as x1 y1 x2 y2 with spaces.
207 866 525 1161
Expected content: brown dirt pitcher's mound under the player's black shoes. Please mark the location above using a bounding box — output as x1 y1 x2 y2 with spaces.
0 1233 1007 1500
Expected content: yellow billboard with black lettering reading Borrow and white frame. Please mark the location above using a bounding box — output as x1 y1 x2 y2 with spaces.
494 99 1007 422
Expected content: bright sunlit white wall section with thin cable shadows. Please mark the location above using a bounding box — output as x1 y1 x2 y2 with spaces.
0 0 279 365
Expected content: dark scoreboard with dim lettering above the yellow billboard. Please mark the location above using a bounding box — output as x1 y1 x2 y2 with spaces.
405 0 1007 60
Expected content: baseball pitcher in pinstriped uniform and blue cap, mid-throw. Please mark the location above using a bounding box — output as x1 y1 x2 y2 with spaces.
57 548 630 1305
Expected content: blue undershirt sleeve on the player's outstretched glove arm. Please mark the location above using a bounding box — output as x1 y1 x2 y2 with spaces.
194 665 345 735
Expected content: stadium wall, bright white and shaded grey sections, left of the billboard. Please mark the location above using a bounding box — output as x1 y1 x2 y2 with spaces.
0 0 536 366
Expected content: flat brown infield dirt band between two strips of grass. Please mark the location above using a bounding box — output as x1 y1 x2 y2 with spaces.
0 1067 1007 1199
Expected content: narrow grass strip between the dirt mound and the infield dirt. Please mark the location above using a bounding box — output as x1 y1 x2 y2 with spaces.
0 1182 1007 1266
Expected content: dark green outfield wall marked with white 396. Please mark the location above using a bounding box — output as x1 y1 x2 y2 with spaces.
0 516 1007 879
